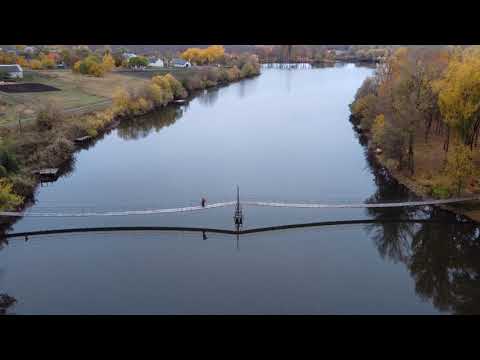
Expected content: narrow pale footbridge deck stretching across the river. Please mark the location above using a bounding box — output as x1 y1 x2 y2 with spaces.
0 196 480 217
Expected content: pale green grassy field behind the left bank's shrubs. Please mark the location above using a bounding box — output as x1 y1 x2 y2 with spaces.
0 70 148 126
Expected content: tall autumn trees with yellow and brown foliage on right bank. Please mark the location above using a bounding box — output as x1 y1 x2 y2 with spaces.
350 46 480 221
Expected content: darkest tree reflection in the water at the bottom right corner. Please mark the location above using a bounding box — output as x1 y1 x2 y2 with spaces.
407 209 480 313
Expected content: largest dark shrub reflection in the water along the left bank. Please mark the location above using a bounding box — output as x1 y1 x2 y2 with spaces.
117 105 184 140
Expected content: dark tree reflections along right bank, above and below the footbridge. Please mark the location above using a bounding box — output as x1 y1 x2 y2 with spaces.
366 145 480 314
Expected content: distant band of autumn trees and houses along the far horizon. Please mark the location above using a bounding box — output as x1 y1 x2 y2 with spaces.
0 45 398 72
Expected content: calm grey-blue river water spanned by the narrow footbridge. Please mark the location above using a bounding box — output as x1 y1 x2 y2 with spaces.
0 64 480 314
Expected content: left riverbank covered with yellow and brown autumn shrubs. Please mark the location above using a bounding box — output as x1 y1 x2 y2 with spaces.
0 63 260 220
